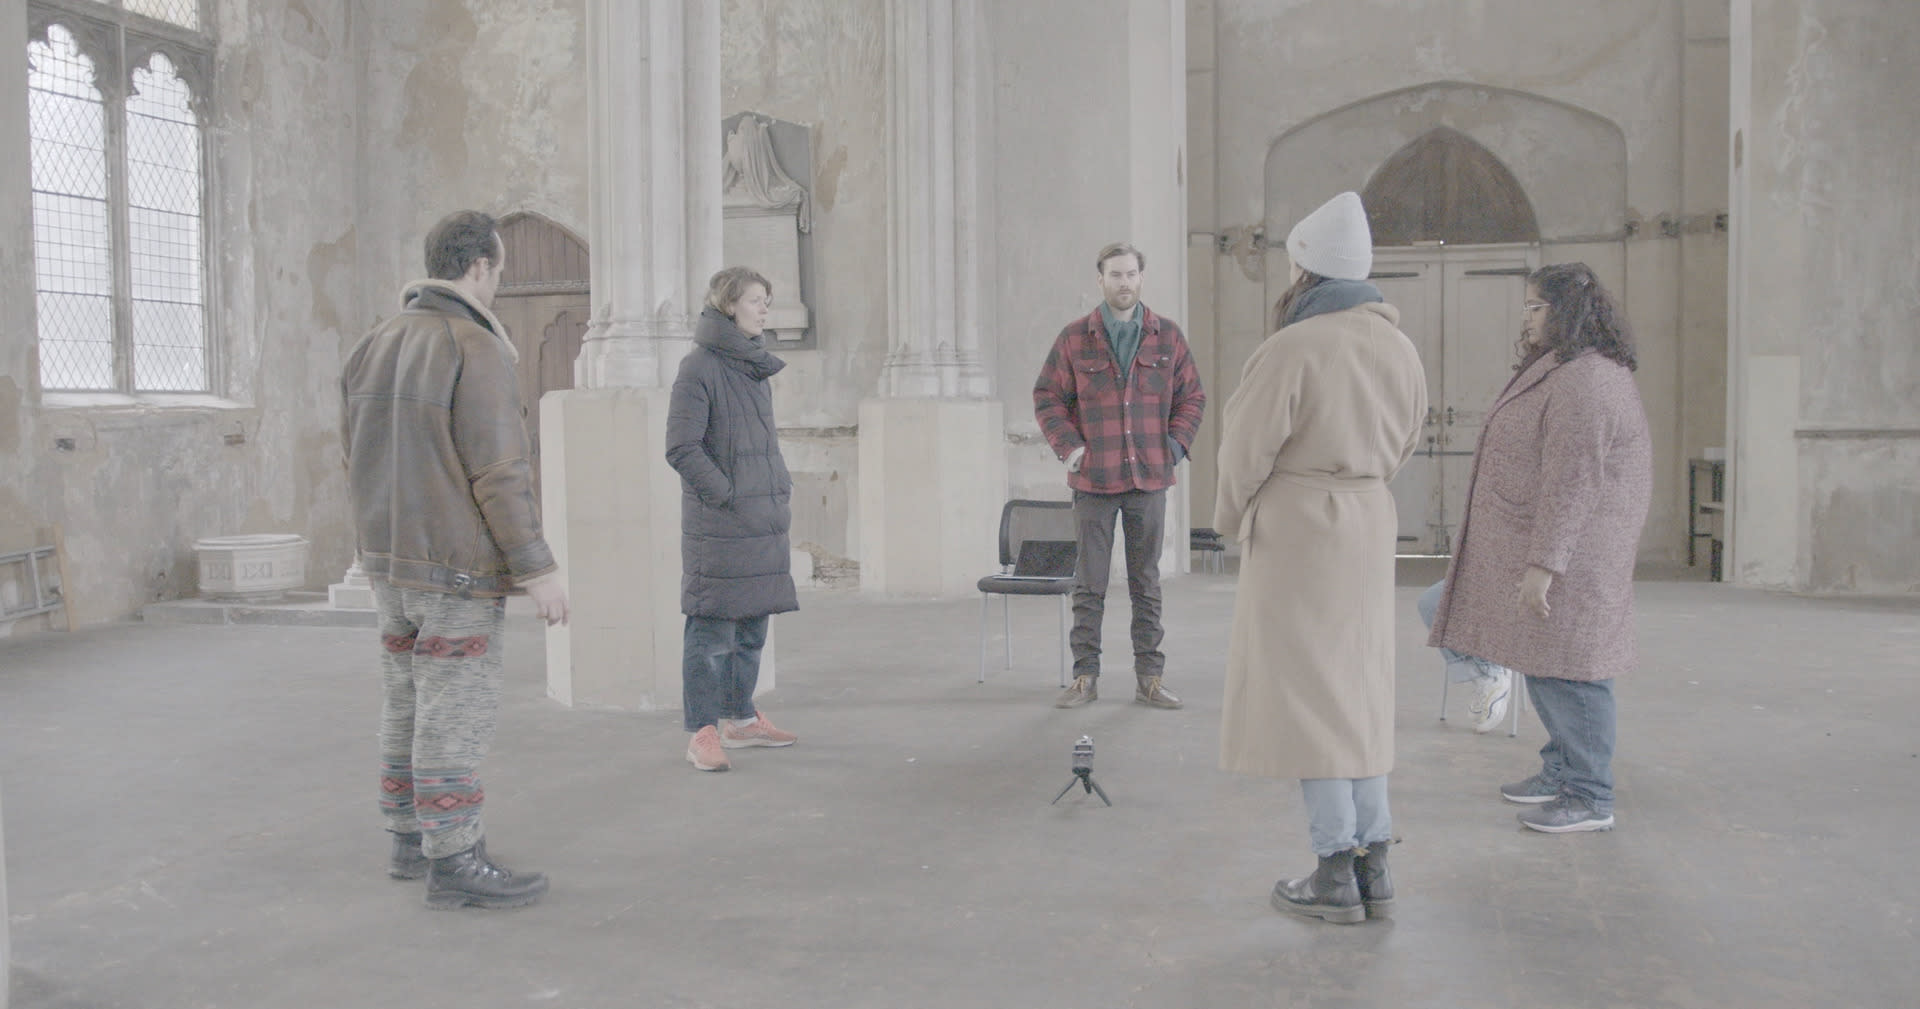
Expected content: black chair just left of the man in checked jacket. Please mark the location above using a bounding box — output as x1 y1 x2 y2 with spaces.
979 501 1079 687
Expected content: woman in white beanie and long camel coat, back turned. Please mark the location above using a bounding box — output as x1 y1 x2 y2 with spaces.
1213 192 1427 923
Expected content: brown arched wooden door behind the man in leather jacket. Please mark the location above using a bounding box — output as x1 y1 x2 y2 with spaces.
493 213 591 498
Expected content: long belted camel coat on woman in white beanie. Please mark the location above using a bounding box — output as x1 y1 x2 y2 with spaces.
1213 303 1427 779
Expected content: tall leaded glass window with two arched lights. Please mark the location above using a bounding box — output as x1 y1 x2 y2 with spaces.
27 0 213 393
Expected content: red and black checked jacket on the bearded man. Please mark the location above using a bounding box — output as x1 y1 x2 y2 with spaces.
1033 305 1206 495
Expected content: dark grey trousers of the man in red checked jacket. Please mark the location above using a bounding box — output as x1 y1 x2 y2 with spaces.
1069 491 1167 677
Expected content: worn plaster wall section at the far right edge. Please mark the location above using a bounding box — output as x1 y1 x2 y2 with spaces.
1726 0 1920 593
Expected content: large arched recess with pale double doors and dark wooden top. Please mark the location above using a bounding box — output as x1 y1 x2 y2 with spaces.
1263 82 1628 554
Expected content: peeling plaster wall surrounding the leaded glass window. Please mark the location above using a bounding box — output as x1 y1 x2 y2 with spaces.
0 0 355 623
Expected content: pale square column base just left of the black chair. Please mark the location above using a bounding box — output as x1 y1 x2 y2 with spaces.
860 399 1006 598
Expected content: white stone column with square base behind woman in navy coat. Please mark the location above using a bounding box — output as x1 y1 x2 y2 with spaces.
540 0 721 710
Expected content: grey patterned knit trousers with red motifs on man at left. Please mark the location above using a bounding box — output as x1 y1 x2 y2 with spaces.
372 577 507 857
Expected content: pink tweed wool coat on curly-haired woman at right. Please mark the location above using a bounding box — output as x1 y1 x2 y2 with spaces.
1427 351 1653 681
